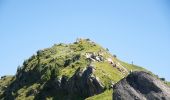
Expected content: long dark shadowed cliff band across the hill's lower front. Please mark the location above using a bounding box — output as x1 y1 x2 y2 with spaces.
36 66 104 100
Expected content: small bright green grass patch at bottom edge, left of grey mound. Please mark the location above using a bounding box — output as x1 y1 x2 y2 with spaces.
85 90 113 100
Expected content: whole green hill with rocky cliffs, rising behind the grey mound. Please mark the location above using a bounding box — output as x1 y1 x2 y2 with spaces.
0 39 149 100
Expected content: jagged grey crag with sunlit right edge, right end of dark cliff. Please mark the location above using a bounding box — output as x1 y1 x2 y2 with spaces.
68 66 104 97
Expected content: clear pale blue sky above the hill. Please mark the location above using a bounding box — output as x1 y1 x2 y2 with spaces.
0 0 170 81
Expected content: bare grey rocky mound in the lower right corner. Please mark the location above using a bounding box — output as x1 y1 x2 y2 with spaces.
113 71 170 100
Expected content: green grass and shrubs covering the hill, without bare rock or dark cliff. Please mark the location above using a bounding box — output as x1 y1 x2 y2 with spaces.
0 39 150 100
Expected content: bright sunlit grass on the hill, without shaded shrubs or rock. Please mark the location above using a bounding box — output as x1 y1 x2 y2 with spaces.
0 40 151 100
